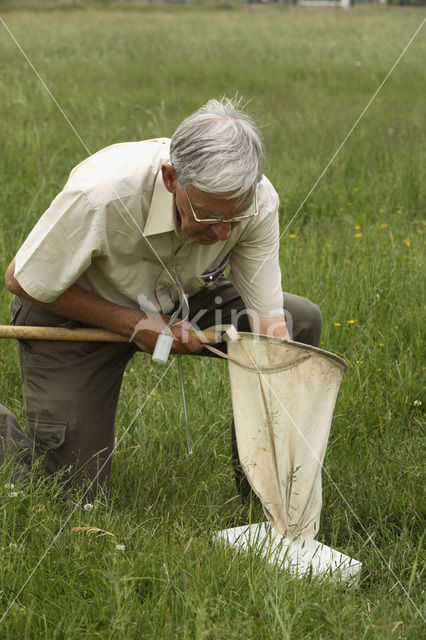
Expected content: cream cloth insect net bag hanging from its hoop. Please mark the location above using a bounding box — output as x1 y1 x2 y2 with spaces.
227 333 347 540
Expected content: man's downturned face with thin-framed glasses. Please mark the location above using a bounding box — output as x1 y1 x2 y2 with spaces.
162 165 252 245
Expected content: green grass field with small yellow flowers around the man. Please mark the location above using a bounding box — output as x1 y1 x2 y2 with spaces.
0 5 426 640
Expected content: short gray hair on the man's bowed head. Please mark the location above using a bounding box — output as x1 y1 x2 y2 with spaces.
170 97 263 198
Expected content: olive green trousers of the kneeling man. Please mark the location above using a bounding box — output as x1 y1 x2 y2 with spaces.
0 277 322 500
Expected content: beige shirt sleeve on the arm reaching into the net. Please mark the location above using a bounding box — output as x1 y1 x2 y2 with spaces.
229 177 283 317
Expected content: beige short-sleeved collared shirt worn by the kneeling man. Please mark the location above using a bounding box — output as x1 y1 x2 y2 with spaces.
15 138 282 316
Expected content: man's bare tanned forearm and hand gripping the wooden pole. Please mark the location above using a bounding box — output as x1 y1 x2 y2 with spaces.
5 259 202 354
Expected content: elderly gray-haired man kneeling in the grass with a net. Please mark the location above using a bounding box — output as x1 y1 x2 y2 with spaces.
0 98 321 498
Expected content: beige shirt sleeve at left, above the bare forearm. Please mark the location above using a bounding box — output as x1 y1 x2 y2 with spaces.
15 186 102 302
